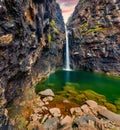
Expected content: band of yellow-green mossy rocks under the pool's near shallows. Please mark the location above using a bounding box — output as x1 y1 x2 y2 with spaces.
56 88 120 112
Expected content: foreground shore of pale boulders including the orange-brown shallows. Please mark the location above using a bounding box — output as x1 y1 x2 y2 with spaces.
7 89 120 130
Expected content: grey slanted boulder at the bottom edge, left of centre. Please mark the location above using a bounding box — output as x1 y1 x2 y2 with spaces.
43 117 59 130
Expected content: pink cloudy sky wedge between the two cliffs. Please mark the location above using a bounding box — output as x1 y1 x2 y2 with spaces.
57 0 79 23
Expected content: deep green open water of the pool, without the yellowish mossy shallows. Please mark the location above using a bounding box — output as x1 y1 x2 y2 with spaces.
36 70 120 103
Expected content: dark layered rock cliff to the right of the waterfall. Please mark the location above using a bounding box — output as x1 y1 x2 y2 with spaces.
68 0 120 75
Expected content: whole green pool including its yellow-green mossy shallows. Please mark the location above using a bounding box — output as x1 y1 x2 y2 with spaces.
36 70 120 111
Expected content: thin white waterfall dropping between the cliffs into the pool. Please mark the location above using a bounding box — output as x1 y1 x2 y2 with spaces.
65 25 70 70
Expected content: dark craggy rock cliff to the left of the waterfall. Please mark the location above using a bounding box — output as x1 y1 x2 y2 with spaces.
0 0 64 129
